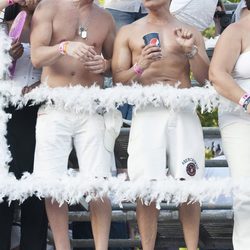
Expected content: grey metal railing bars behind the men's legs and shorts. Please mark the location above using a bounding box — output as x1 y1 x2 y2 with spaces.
69 128 233 249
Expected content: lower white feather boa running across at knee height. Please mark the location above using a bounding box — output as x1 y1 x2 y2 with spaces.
0 171 250 209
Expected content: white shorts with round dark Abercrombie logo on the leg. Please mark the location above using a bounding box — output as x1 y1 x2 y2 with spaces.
128 107 205 180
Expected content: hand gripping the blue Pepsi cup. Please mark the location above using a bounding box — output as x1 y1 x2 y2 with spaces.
137 44 162 70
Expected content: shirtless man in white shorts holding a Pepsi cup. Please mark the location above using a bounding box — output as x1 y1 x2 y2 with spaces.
112 0 209 250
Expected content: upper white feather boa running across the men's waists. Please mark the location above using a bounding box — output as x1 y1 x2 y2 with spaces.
0 81 219 113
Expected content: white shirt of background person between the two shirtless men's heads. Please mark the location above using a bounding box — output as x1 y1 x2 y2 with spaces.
104 0 147 13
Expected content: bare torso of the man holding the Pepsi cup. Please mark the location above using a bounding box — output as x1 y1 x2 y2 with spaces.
128 17 190 87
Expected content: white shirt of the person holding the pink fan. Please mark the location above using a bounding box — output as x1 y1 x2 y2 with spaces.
13 43 42 87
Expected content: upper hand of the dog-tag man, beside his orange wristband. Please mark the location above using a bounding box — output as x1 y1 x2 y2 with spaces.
66 42 96 62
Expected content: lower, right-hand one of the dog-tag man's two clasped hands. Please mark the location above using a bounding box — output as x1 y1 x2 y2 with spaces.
84 55 108 74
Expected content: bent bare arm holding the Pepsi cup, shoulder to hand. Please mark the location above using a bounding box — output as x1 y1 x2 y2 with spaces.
112 25 162 84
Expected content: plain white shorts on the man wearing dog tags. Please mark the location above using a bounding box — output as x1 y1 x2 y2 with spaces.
34 106 114 177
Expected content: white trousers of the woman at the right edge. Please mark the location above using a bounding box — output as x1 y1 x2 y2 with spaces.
221 123 250 250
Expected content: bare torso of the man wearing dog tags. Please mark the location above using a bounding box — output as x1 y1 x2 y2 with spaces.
42 1 109 87
